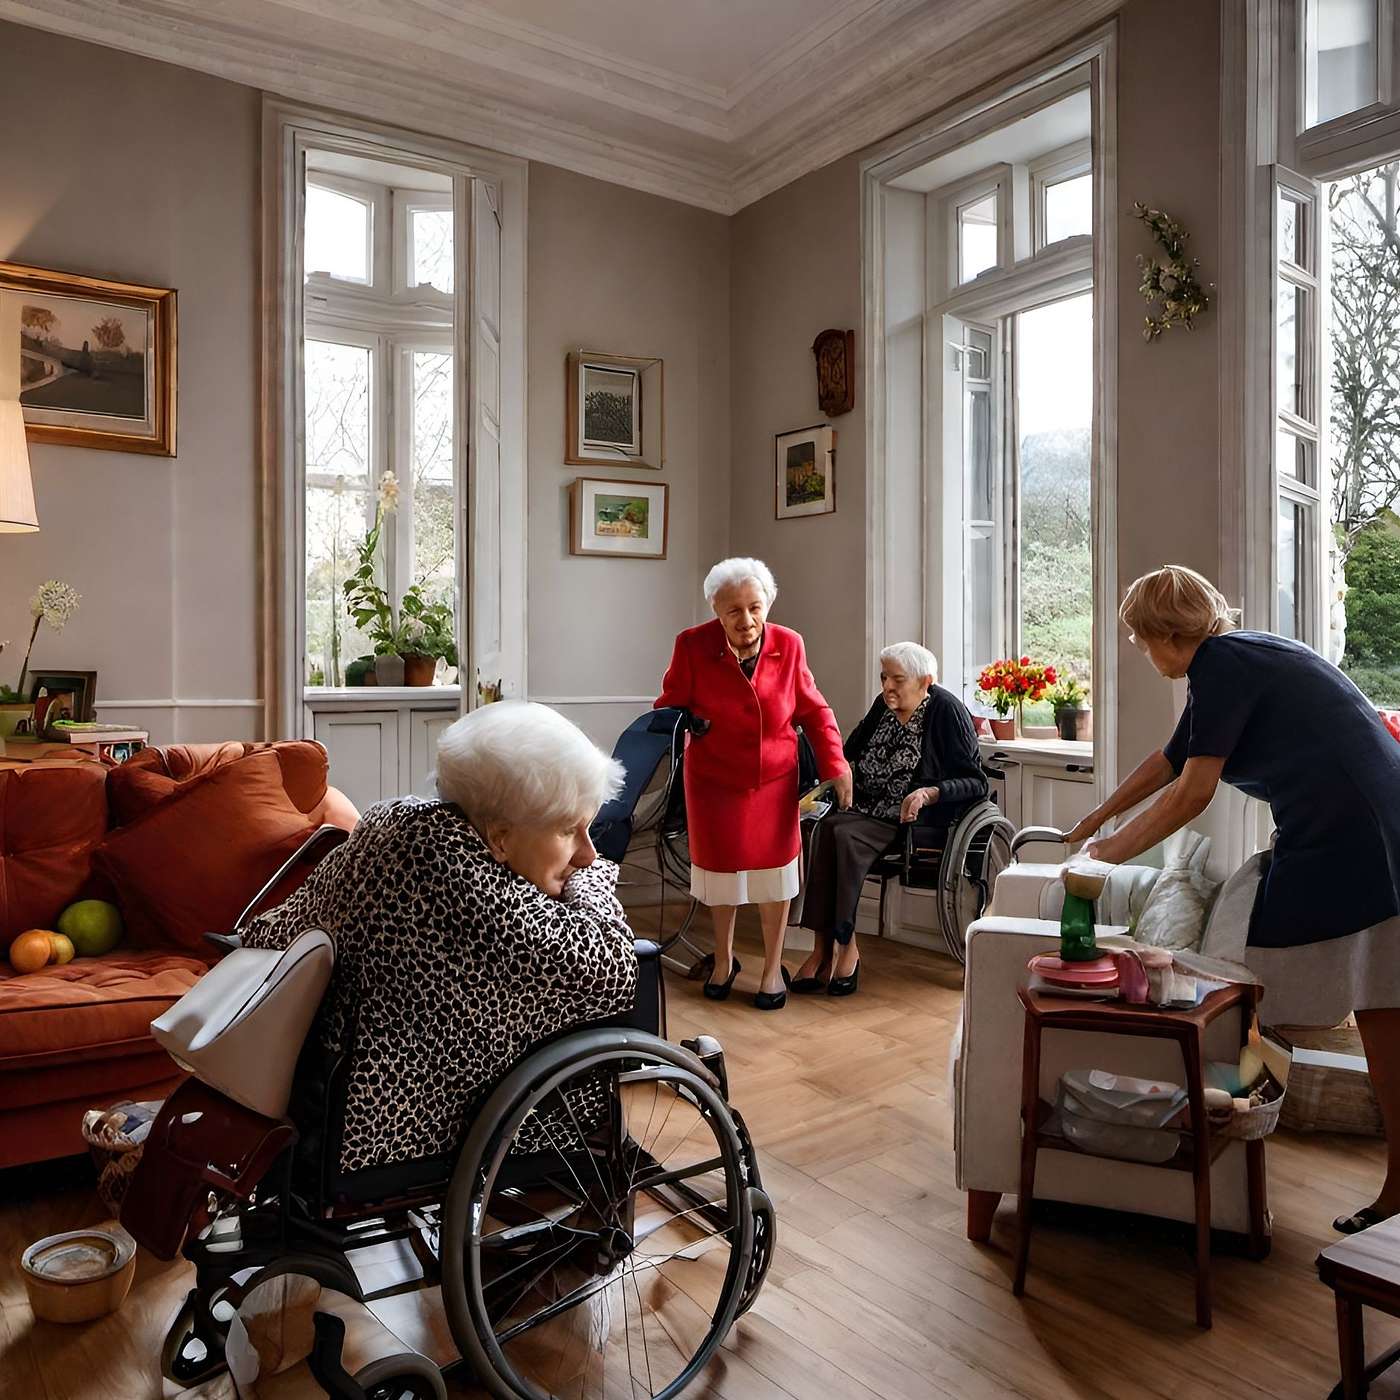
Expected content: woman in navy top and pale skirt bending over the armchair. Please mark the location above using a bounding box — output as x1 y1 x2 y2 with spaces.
1070 564 1400 1233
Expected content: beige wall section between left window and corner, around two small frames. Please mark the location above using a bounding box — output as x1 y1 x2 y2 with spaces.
528 165 729 743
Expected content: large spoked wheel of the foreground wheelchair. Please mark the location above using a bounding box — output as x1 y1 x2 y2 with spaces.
442 1030 770 1400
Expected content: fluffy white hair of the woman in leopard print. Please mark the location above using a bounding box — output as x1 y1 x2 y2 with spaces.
437 700 623 832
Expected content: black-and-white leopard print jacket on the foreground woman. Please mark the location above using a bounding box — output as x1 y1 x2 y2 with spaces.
244 798 637 1172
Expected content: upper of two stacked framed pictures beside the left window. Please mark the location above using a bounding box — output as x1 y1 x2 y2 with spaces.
564 350 665 470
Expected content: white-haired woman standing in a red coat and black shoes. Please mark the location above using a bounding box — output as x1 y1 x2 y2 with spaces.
657 559 851 1011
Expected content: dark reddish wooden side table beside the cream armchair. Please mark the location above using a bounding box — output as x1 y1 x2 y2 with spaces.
1012 984 1268 1327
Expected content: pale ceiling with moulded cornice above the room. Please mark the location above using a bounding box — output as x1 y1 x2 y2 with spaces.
0 0 1120 213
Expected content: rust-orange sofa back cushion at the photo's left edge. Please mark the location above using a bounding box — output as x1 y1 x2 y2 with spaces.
0 763 106 953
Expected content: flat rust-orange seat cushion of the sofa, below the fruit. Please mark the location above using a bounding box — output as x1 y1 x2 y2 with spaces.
0 948 207 1074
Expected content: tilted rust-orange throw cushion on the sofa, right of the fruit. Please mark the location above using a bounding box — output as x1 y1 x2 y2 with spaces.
95 749 315 951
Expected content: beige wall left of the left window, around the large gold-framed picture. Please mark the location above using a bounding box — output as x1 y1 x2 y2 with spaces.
0 24 260 739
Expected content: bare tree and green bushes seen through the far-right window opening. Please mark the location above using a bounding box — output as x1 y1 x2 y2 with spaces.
1327 161 1400 704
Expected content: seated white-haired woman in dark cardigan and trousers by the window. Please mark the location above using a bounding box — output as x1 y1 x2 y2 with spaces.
792 641 1009 997
